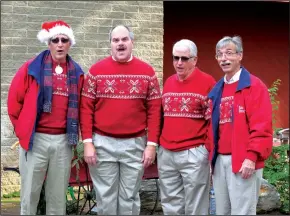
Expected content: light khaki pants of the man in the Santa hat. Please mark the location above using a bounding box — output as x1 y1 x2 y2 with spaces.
19 133 72 215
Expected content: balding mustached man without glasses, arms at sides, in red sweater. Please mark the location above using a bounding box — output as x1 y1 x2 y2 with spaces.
80 25 161 215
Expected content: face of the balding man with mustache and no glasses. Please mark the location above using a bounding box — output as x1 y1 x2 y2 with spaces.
111 26 133 62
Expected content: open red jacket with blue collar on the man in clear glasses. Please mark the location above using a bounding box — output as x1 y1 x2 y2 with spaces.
208 67 273 173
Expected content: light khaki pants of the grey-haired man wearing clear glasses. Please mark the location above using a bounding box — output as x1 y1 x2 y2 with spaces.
212 155 263 215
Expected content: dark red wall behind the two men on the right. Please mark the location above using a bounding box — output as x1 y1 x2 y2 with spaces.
163 1 289 128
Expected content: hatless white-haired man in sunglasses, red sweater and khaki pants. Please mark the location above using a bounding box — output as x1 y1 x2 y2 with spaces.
157 39 215 215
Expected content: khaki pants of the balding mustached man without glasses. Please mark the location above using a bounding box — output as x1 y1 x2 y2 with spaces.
89 134 146 215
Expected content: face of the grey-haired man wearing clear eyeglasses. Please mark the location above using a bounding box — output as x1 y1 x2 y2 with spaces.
216 43 243 74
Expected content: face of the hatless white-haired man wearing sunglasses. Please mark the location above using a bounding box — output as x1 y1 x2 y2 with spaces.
173 47 197 80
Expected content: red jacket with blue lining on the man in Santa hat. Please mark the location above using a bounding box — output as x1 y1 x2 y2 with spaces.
7 54 84 151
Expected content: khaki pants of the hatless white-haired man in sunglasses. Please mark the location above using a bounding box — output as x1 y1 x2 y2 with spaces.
157 145 210 215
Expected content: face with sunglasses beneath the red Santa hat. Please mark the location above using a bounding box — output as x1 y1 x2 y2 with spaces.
48 34 71 63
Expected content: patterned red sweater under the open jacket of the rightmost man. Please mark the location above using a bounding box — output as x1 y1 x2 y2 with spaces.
218 82 238 154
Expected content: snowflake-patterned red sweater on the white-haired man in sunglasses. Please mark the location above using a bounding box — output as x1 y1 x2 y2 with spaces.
160 68 215 151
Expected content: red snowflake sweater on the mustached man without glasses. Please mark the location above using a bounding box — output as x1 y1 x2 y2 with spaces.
80 56 161 143
